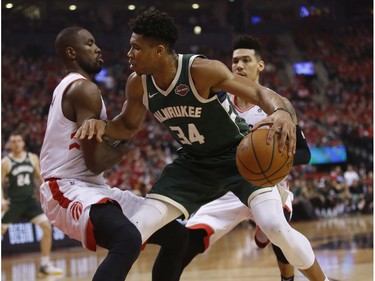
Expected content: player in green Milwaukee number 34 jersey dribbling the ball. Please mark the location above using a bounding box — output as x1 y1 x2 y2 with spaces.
75 8 328 281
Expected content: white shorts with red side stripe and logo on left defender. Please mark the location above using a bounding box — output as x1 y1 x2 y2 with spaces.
40 179 144 251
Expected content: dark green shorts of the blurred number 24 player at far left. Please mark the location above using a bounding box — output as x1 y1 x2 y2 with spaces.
1 198 43 224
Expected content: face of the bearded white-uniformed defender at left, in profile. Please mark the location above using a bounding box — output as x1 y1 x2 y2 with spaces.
74 29 103 74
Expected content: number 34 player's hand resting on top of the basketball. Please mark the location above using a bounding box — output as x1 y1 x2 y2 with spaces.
251 110 296 157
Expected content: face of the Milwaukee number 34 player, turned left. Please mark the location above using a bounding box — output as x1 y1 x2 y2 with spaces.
128 33 161 75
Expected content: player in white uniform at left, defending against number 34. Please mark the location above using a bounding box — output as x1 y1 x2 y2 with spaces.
40 27 147 281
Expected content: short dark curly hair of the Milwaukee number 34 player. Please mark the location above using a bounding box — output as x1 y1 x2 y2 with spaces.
129 7 178 52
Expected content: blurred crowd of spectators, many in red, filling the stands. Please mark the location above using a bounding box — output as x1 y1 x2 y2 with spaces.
2 2 373 220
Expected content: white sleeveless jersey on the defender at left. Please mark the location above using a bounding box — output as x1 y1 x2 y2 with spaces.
40 73 107 184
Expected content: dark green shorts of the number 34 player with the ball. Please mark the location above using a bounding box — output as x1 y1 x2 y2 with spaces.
148 148 262 219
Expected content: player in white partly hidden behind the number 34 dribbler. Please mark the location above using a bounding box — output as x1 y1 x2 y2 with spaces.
175 36 316 281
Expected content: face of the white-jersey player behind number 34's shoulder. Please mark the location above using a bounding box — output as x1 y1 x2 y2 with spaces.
232 49 264 82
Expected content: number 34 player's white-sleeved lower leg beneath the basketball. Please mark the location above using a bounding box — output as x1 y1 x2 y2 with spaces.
250 188 326 281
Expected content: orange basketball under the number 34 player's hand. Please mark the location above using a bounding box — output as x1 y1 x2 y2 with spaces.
236 128 293 187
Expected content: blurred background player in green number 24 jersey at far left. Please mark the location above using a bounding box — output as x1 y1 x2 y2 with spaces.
1 133 62 275
